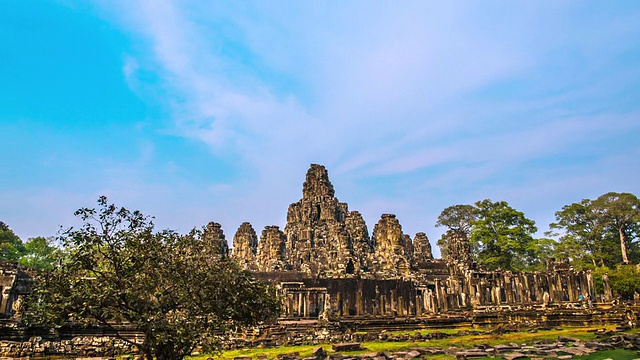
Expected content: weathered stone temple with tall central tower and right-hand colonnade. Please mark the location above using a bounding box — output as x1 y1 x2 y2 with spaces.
232 164 595 319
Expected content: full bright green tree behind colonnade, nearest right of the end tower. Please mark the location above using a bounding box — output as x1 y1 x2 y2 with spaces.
470 199 544 270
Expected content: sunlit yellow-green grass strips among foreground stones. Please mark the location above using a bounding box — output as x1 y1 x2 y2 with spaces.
192 326 620 360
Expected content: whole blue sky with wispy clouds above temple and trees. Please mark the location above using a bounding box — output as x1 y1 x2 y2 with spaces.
0 0 640 253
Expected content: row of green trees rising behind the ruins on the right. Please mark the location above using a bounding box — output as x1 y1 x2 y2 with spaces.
436 192 640 299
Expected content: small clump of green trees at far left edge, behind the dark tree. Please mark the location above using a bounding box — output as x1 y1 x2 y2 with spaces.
0 221 61 270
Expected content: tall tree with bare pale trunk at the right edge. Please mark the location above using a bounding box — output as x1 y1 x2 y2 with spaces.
592 192 640 264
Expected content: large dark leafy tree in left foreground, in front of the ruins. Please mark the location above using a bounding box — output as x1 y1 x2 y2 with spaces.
25 197 278 360
